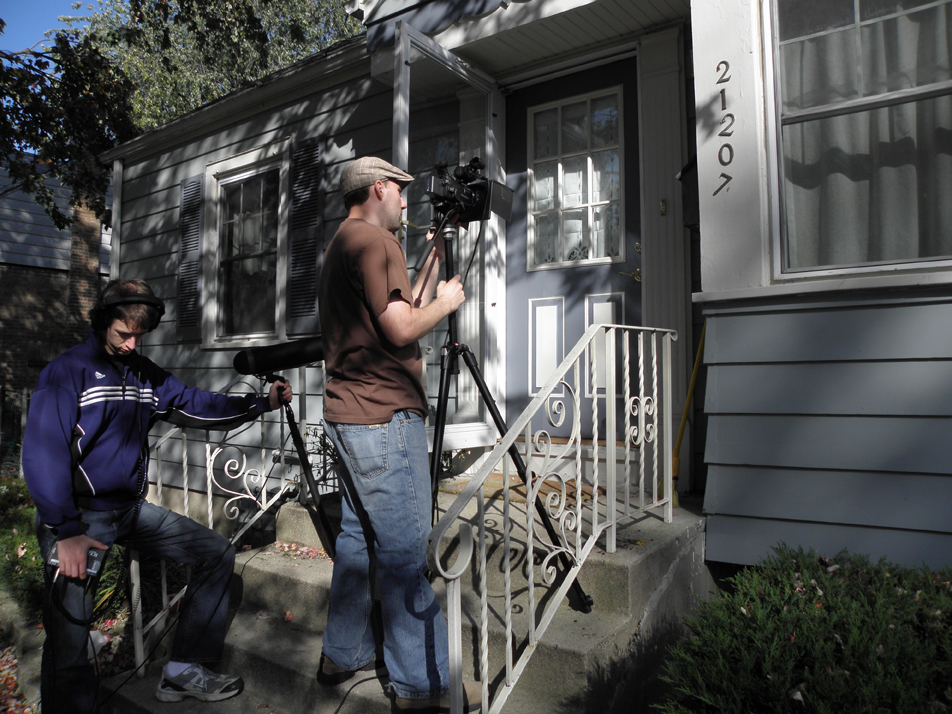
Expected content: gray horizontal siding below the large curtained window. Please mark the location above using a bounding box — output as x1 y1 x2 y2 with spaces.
704 293 952 567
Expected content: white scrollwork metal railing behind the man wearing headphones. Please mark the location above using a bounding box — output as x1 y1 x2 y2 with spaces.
130 376 336 677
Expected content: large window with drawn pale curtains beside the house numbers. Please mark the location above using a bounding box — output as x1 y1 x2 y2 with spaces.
773 0 952 272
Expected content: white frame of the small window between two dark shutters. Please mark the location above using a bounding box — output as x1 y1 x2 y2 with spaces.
202 137 291 348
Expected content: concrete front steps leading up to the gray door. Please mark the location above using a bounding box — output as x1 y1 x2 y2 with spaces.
104 490 710 714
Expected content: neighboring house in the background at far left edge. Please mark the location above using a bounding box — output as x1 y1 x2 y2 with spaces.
0 168 110 441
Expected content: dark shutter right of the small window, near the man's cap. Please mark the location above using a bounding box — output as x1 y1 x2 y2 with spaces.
287 138 324 335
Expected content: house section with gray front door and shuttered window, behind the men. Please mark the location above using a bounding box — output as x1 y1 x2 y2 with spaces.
104 1 694 508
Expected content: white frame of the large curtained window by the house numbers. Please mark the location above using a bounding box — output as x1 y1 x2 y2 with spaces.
760 0 952 280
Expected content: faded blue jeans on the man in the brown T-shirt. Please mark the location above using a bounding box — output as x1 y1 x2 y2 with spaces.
323 412 449 699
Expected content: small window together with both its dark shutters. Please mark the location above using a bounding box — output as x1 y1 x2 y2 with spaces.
178 137 324 347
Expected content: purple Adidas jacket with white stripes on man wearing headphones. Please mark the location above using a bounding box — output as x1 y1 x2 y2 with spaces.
23 331 270 540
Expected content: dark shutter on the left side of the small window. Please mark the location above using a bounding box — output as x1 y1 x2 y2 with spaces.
178 175 205 341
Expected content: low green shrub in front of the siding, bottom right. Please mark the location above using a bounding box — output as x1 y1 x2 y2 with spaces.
658 545 952 714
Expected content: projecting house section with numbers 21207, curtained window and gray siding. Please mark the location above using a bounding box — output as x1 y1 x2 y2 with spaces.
691 0 952 567
